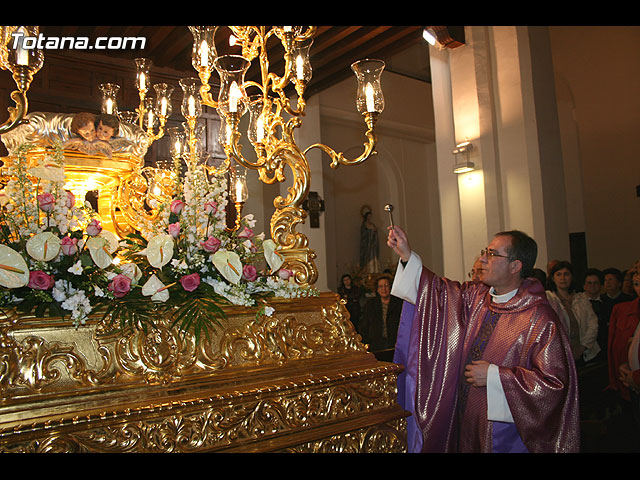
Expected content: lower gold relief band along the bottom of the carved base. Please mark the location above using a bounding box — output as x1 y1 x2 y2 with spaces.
0 367 402 453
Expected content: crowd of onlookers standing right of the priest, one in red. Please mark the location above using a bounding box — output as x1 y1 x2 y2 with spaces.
538 261 640 451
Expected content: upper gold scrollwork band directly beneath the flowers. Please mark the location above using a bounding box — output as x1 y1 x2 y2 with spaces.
0 295 366 395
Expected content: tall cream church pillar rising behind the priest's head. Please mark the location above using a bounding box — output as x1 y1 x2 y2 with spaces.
430 26 569 280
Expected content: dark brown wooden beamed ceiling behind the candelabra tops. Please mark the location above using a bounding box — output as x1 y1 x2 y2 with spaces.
35 25 423 97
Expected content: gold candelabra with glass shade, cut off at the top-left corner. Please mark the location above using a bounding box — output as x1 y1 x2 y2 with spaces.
0 26 44 134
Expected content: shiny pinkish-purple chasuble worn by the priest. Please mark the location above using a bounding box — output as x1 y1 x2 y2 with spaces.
407 268 580 452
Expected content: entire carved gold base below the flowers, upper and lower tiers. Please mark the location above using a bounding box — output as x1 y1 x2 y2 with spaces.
0 294 406 452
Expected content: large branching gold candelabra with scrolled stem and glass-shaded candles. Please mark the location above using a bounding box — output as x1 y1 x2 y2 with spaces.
189 26 384 285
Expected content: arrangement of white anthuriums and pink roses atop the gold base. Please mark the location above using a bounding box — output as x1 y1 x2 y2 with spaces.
0 145 317 337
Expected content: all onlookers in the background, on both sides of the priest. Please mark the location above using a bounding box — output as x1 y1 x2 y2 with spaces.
338 246 640 451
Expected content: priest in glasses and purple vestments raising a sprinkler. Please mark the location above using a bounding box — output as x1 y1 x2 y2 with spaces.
387 226 580 453
